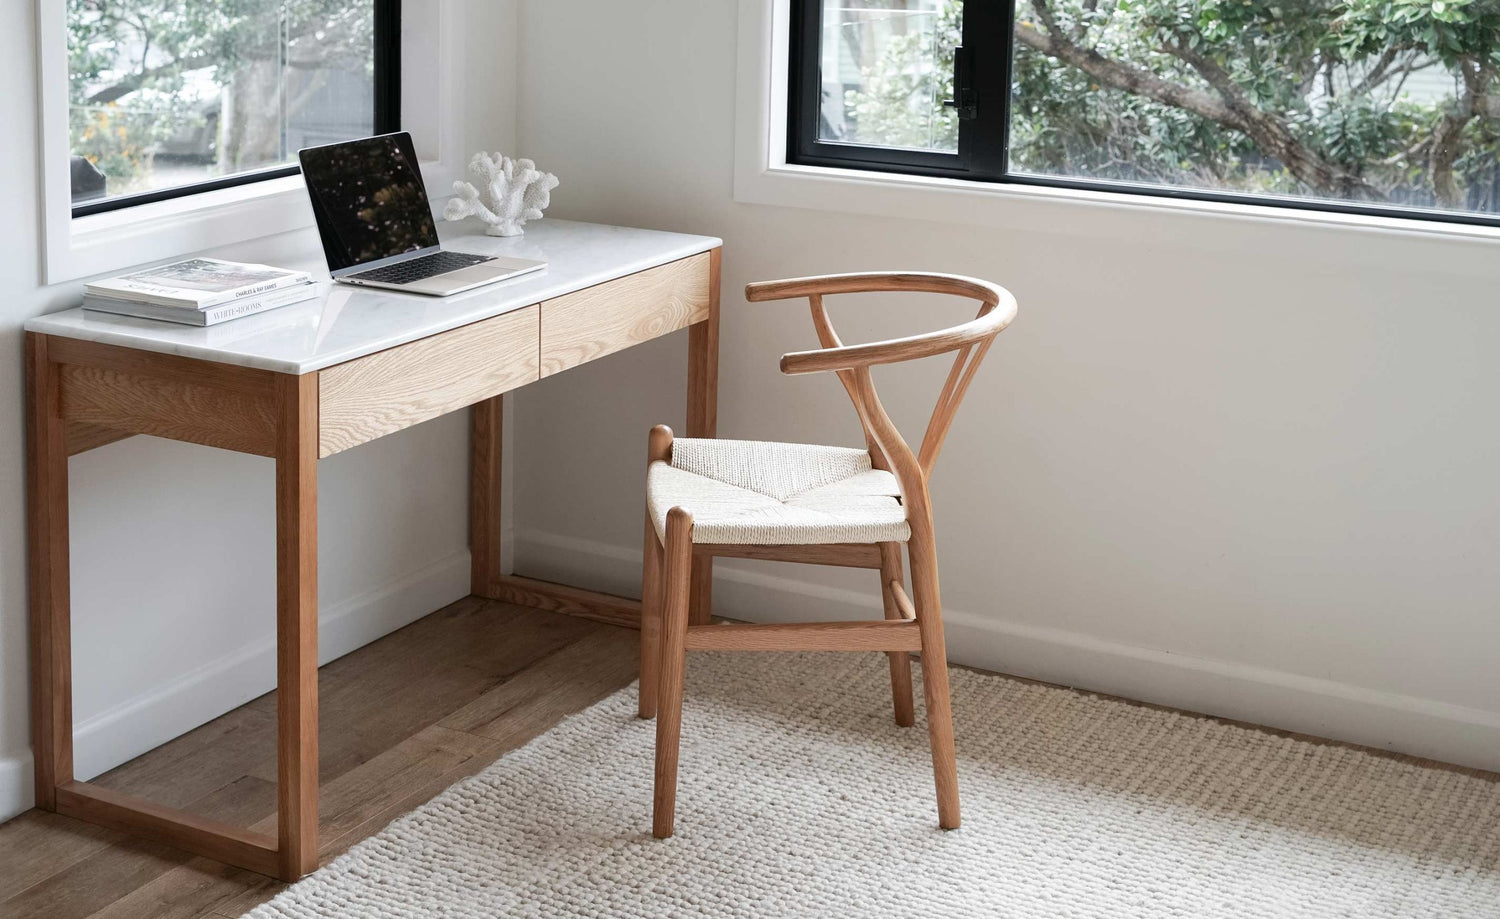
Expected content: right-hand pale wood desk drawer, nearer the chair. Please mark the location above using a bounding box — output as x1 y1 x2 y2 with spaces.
542 252 710 376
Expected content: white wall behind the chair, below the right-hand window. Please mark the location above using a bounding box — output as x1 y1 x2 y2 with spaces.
516 0 1500 769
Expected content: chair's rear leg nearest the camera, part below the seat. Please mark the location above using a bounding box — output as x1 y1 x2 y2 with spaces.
908 540 960 829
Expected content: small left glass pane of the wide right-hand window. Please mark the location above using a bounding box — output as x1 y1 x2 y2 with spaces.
818 0 963 151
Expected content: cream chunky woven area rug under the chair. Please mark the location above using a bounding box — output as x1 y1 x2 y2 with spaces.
249 652 1500 919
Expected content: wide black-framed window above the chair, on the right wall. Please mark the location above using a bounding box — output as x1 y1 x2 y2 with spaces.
788 0 1500 223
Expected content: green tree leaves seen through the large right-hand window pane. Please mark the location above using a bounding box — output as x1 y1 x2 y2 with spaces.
1013 0 1500 210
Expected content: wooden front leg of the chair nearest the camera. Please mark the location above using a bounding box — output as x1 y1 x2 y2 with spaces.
651 507 693 840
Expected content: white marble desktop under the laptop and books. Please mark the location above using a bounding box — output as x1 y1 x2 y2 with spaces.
26 217 720 373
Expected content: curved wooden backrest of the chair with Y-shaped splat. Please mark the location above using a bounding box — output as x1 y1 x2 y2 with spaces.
746 271 1016 541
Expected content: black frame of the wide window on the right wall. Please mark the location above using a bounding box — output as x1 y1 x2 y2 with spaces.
786 0 1500 226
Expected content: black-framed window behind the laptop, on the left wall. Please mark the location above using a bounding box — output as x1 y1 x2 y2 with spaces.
66 0 401 217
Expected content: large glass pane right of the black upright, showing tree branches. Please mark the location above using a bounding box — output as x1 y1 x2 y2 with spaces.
1010 0 1500 213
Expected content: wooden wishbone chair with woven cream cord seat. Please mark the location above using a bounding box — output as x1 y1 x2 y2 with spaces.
639 271 1016 838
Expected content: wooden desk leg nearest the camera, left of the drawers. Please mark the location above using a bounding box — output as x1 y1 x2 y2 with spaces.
276 373 318 880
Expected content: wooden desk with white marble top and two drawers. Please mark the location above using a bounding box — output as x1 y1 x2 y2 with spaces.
26 220 722 880
